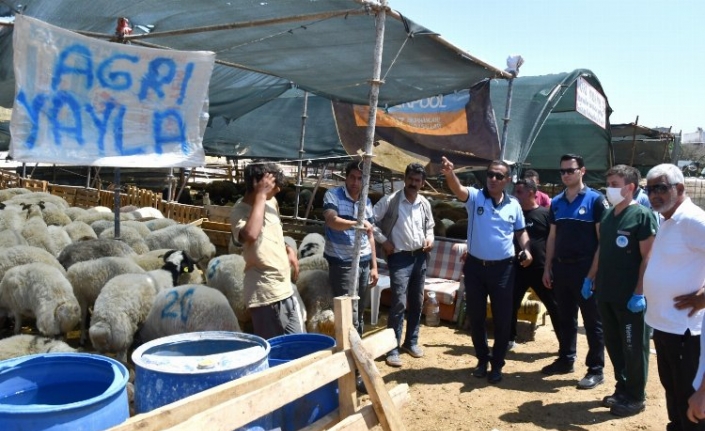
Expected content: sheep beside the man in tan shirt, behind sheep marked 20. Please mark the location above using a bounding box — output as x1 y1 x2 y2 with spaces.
205 254 252 327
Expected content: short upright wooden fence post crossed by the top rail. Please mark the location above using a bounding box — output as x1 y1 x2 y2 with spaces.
333 296 358 418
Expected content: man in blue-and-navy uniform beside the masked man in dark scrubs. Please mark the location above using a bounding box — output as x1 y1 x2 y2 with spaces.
541 154 609 389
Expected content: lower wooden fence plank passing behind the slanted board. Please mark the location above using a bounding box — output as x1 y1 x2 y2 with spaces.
299 383 411 431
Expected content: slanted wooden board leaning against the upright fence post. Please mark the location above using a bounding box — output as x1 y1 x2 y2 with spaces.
350 329 406 431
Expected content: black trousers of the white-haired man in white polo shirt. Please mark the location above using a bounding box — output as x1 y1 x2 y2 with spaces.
654 329 705 431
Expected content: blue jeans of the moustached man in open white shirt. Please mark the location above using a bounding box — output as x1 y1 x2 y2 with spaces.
387 252 428 354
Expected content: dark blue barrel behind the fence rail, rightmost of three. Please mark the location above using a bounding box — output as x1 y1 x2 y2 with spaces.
268 334 338 431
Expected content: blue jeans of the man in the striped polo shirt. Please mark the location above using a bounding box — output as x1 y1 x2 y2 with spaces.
326 258 370 335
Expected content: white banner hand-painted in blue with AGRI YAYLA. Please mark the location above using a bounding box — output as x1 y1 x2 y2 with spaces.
10 15 215 167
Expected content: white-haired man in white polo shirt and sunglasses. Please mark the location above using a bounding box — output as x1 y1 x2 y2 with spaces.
644 163 705 431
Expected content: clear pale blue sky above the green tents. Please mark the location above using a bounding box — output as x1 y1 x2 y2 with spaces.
388 0 705 133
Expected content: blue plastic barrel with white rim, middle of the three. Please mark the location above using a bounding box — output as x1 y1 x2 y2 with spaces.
132 331 271 430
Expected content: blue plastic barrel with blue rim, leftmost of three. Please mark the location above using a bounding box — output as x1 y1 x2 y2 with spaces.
0 353 130 431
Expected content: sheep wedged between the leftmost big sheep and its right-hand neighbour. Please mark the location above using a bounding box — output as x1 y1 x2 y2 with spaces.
66 256 147 345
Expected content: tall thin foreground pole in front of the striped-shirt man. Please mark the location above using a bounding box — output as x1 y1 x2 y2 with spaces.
341 0 387 318
